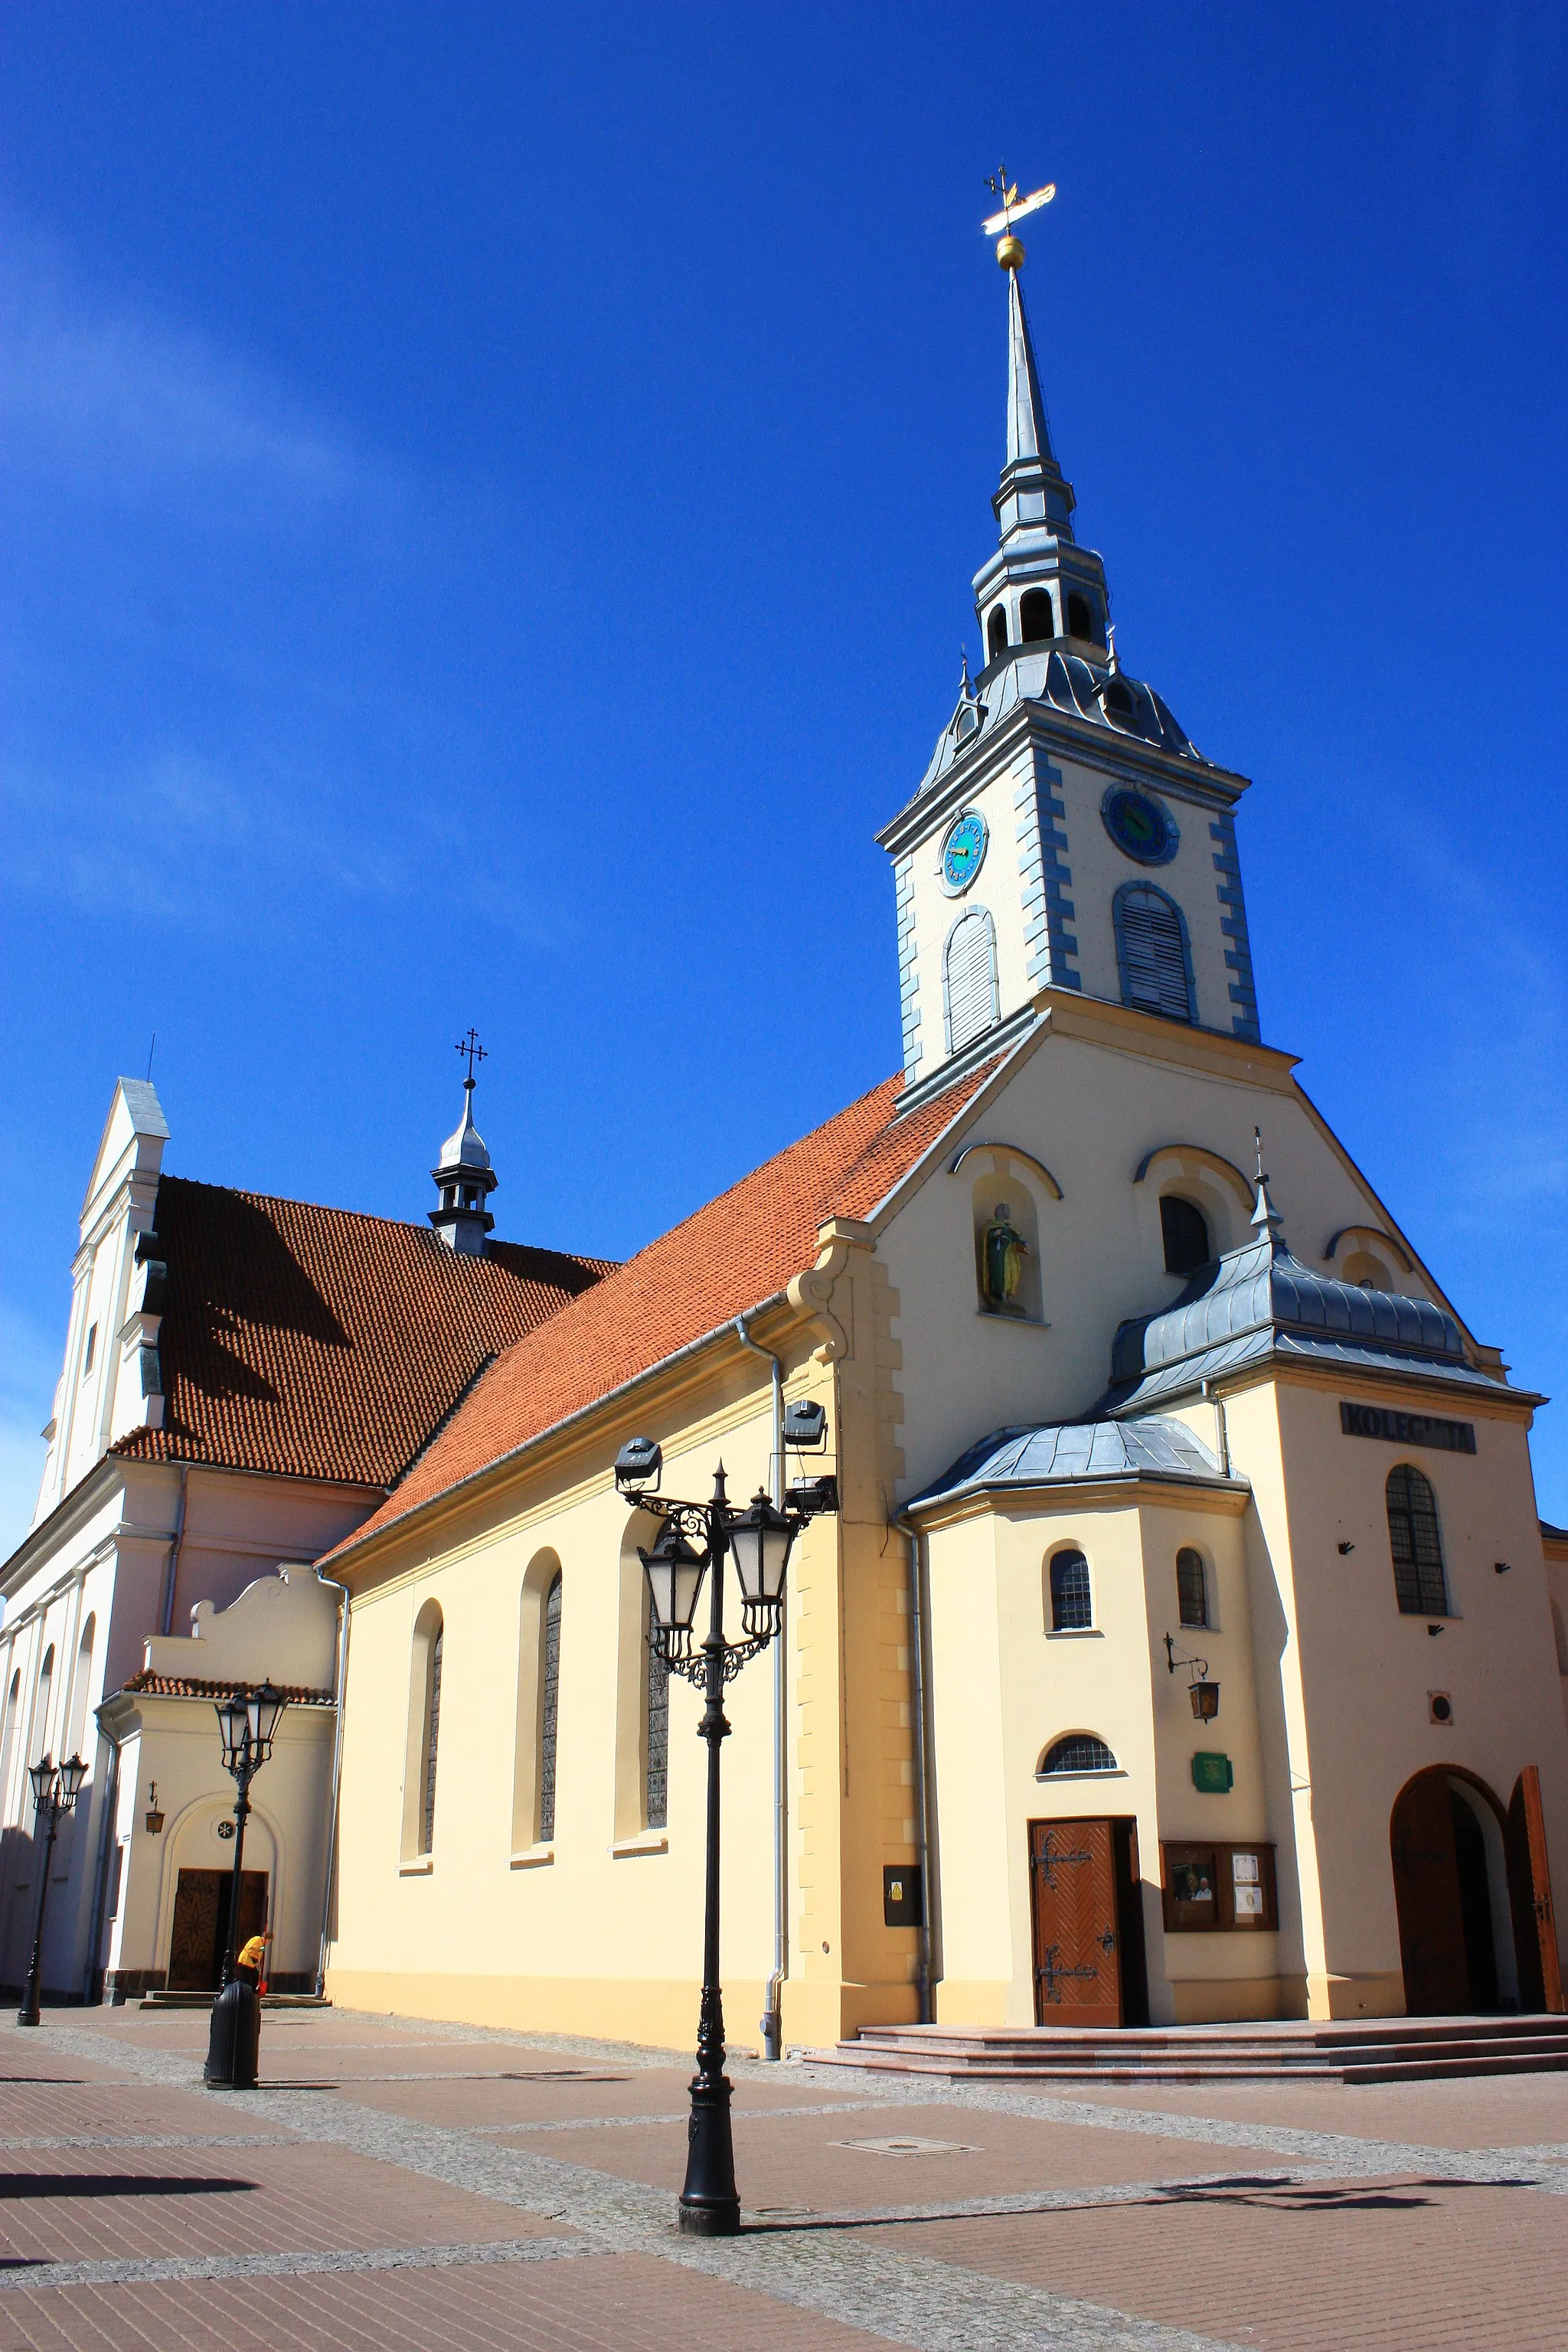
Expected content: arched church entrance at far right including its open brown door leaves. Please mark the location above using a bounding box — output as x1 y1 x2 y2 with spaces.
1390 1764 1563 2018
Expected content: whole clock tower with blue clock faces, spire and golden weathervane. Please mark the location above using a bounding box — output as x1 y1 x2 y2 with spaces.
877 176 1258 1108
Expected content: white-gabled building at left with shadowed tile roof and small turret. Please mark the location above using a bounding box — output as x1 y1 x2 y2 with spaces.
0 1067 604 2001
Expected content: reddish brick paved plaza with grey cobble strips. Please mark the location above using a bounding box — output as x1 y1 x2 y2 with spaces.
0 2008 1568 2352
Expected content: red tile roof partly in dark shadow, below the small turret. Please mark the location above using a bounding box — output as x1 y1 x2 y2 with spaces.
115 1176 609 1487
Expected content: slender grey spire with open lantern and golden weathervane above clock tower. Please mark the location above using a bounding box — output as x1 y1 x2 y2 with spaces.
973 176 1109 668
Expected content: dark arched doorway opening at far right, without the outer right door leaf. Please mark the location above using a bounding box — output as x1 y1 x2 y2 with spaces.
1390 1764 1519 2018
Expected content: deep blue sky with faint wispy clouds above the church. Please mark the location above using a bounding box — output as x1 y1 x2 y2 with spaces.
0 0 1568 1547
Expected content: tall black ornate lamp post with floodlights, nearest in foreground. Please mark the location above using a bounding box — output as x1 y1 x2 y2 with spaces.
616 1402 839 2236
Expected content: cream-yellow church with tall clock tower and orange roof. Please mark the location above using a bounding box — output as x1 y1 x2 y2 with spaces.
322 237 1568 2047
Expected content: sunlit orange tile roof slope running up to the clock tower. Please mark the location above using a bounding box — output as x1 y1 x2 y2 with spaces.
329 1063 995 1557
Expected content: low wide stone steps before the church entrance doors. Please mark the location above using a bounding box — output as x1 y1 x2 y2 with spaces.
808 2016 1568 2084
